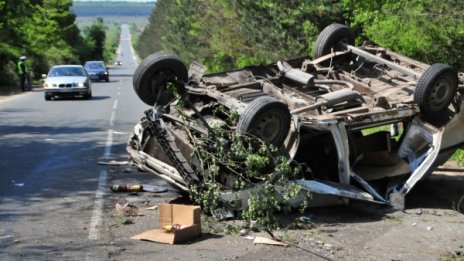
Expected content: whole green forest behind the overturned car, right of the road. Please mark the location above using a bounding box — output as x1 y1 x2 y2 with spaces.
136 0 464 72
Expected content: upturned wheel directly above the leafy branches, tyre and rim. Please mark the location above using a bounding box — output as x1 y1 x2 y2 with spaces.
237 96 291 147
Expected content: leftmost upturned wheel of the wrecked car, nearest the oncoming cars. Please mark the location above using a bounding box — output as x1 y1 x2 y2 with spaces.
133 52 188 106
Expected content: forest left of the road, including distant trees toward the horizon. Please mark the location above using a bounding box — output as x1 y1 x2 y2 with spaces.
0 0 134 86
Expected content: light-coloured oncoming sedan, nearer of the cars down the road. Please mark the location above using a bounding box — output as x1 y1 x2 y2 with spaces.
43 65 92 101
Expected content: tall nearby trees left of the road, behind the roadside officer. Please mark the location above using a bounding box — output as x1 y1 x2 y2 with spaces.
0 0 83 83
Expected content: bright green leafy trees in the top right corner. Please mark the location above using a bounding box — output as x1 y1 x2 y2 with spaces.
342 0 464 69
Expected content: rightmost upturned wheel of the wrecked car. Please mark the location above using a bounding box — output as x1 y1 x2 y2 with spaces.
414 63 458 115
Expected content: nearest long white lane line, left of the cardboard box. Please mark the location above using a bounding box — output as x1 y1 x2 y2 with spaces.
89 129 113 240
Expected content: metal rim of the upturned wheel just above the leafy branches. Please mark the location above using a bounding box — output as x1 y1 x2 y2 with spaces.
252 111 282 143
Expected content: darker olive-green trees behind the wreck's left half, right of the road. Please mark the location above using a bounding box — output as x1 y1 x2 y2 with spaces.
136 0 343 71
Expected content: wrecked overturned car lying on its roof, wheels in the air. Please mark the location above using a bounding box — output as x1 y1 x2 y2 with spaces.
127 24 464 208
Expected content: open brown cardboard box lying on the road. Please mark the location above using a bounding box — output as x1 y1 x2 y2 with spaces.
132 204 201 244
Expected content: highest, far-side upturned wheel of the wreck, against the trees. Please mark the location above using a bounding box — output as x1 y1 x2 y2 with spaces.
314 24 354 66
